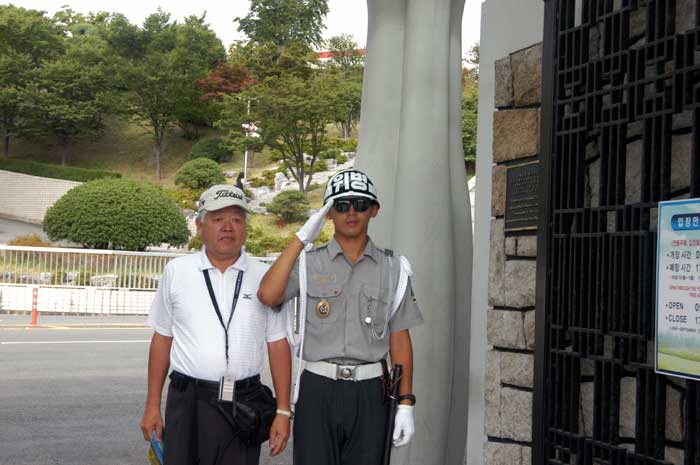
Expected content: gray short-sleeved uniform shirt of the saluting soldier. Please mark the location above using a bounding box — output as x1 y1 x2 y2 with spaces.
285 238 423 364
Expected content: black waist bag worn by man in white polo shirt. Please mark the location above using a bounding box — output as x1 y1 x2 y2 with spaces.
214 384 277 446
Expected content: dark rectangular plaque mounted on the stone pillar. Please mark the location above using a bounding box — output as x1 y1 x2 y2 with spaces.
505 161 540 232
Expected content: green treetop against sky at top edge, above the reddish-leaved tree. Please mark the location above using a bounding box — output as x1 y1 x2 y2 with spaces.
235 0 328 48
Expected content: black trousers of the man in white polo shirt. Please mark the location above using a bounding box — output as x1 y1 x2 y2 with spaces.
163 374 260 465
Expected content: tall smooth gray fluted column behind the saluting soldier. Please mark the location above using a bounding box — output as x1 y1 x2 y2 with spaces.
356 0 472 465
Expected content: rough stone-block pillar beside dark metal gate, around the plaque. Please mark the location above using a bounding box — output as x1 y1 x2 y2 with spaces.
484 44 542 465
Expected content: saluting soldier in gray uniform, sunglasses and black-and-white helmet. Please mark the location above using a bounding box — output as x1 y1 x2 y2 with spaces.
258 170 423 465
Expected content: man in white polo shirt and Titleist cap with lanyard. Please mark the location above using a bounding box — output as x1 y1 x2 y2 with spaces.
141 185 291 465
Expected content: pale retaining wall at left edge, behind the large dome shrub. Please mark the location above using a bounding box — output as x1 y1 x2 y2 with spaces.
0 170 80 224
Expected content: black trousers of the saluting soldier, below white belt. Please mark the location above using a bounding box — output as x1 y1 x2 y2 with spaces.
294 371 388 465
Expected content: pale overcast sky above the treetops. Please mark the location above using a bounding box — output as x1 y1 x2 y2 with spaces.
12 0 483 51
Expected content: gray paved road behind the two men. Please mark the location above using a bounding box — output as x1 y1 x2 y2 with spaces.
0 322 291 465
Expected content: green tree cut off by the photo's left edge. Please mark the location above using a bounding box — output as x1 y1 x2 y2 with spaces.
0 5 63 159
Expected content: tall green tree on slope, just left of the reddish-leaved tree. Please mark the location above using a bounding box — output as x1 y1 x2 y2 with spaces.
110 10 225 179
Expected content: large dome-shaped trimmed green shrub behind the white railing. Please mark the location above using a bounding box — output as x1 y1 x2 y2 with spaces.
43 179 190 250
